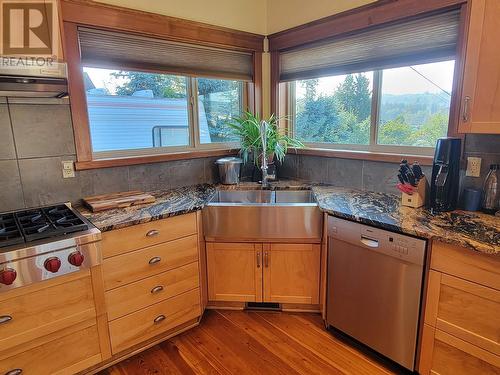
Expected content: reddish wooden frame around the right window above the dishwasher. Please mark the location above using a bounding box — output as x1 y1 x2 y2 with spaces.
268 0 470 165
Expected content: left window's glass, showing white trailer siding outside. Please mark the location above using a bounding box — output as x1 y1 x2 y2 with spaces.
83 67 244 158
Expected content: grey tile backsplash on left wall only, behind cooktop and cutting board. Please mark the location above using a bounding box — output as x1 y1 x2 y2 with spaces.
0 98 221 211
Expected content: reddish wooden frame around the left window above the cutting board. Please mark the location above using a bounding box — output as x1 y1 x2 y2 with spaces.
60 0 264 170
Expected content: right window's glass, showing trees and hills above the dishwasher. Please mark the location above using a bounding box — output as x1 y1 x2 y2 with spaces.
290 60 454 154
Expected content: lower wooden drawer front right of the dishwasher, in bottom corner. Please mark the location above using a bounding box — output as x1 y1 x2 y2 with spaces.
431 330 500 375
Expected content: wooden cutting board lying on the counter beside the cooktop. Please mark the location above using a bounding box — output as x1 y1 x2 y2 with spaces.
83 191 156 212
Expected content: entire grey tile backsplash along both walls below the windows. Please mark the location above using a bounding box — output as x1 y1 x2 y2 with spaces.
0 97 500 211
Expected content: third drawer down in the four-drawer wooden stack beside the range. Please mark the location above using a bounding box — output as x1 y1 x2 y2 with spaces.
106 262 200 320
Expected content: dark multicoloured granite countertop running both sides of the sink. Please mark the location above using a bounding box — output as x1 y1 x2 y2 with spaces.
77 180 500 254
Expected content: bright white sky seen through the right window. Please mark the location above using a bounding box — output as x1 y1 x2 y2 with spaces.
296 61 455 98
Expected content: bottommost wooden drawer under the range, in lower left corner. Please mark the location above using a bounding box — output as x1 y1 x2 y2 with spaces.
0 320 101 375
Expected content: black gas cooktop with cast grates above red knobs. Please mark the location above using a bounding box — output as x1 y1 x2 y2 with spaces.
0 204 89 248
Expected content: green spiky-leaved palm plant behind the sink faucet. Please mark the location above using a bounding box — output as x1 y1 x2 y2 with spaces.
228 111 304 165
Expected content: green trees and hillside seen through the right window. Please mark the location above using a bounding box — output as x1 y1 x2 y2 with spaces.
296 73 450 147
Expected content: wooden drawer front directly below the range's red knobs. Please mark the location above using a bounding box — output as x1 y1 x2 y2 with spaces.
0 271 96 350
